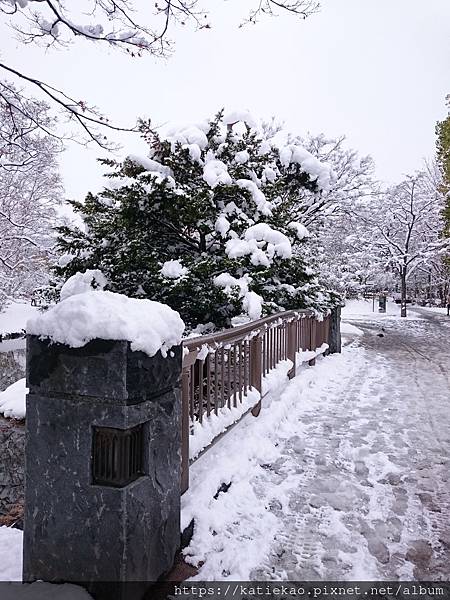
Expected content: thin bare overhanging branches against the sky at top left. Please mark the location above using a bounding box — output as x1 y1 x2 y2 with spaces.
0 0 319 148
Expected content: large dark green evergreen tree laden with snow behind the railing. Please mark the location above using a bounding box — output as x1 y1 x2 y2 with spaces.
57 111 333 328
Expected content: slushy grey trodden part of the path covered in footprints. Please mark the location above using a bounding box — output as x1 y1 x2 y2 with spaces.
252 309 450 581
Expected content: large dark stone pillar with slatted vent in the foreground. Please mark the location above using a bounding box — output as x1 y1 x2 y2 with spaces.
23 336 182 600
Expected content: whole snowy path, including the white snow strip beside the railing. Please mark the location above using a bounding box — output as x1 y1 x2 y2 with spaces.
186 311 450 580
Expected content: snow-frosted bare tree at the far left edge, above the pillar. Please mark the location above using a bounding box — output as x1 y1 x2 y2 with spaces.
0 96 63 306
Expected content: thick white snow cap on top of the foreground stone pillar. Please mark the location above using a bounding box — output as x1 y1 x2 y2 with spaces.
27 291 184 356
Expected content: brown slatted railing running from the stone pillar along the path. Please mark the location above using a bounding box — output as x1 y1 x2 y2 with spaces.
181 310 329 493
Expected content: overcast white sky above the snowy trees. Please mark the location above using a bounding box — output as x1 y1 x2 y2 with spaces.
0 0 450 199
